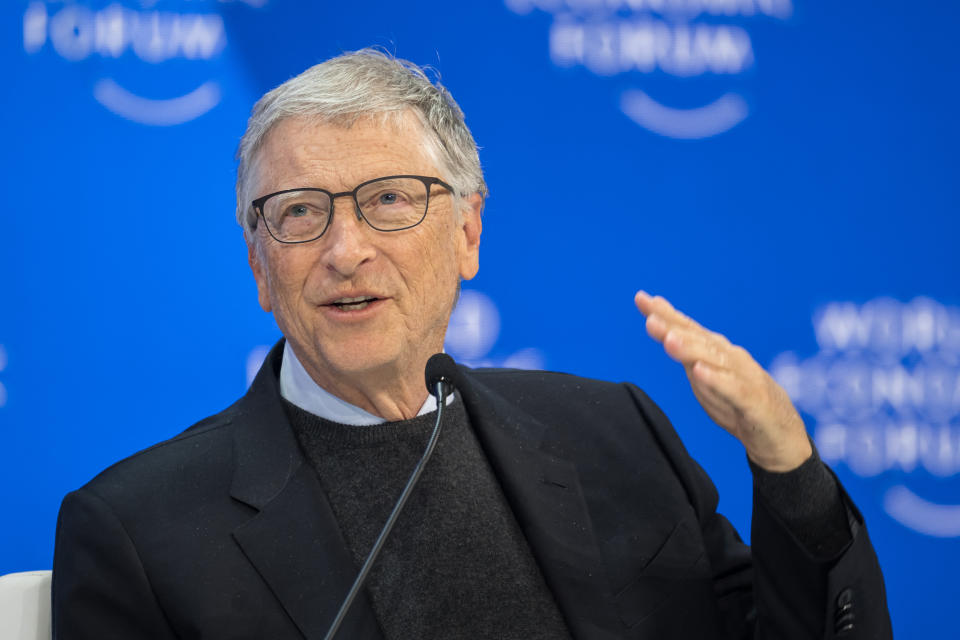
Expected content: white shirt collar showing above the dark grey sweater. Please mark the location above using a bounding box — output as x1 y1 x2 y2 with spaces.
280 342 438 427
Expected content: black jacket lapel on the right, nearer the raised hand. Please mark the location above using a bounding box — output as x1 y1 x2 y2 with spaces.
458 371 623 640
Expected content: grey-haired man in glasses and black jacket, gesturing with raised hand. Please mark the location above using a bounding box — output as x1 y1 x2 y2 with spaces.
53 51 890 639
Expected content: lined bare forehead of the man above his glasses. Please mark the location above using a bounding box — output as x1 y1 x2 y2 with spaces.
253 113 437 195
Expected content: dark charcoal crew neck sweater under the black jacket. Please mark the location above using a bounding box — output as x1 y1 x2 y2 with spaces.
284 398 570 640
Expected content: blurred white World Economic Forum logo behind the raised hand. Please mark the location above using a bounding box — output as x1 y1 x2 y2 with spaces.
770 298 960 537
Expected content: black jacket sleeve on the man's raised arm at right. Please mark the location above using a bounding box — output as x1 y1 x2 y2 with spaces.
630 385 893 640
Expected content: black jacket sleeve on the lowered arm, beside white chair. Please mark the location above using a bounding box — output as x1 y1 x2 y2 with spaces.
52 489 176 640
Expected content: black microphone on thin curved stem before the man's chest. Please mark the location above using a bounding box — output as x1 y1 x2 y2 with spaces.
324 353 460 640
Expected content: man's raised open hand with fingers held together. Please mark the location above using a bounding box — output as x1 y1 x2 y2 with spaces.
634 291 813 472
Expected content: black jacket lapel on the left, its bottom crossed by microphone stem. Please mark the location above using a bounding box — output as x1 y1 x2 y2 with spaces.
230 341 381 640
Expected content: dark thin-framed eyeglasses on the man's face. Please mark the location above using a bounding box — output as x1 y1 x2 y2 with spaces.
252 176 453 244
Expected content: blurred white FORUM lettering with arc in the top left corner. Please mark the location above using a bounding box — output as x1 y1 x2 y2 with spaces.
23 0 267 126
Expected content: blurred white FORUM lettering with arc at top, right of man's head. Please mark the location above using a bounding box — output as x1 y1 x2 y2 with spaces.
505 0 793 139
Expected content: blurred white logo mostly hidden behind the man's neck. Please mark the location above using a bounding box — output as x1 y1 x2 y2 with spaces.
246 289 544 386
